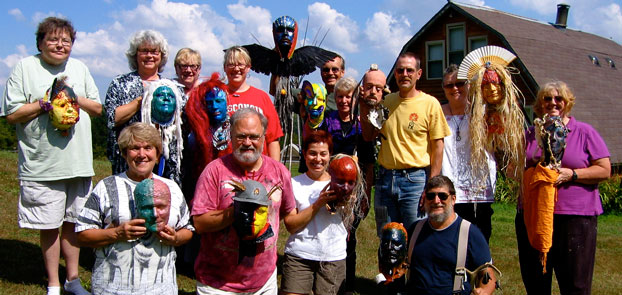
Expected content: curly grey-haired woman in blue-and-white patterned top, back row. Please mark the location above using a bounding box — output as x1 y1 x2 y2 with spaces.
105 30 183 180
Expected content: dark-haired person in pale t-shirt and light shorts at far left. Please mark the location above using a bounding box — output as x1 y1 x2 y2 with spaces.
0 17 102 295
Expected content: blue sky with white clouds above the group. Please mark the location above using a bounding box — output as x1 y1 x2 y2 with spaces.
0 0 622 99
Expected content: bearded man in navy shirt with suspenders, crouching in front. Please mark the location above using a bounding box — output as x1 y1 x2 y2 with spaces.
406 175 495 294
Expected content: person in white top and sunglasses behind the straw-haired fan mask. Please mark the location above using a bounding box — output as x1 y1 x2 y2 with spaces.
441 64 497 242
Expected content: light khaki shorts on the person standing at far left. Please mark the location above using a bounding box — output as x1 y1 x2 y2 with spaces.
17 177 92 229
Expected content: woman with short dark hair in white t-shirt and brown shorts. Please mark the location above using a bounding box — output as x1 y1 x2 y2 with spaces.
281 130 348 294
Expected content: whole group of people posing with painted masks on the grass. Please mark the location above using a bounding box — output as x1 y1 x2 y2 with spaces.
0 17 611 295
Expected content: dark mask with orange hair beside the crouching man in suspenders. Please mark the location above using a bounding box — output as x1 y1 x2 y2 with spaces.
378 222 408 284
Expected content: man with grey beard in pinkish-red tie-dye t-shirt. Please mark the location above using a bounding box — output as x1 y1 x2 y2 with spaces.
191 108 297 295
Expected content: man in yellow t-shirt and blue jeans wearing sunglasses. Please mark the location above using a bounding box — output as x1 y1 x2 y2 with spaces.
362 52 450 232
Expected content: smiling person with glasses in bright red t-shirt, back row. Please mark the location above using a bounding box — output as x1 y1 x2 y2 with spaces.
223 46 283 161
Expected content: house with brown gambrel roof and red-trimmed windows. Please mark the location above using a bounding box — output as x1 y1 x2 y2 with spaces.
388 1 622 163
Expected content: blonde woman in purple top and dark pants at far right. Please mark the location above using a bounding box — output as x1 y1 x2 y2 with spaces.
515 81 611 294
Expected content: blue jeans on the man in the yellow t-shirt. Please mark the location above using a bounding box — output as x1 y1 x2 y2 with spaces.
374 166 427 236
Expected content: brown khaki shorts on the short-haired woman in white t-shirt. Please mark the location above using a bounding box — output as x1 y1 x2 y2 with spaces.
281 254 346 295
